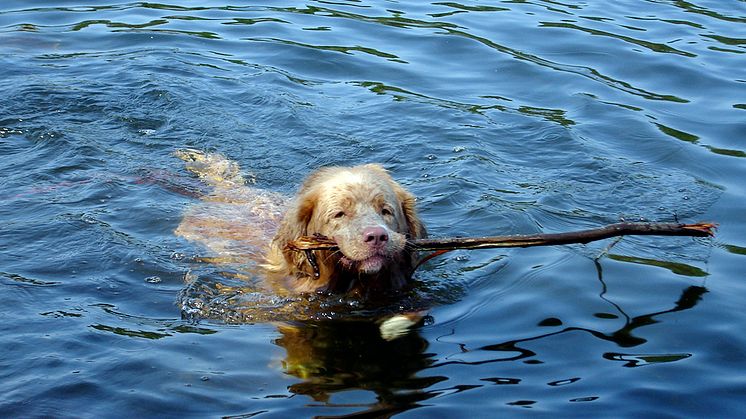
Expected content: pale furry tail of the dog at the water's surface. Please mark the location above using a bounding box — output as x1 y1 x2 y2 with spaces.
174 148 253 188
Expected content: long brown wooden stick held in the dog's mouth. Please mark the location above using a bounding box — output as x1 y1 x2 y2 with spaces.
287 223 717 251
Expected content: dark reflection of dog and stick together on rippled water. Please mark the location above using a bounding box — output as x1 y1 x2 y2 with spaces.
247 268 707 417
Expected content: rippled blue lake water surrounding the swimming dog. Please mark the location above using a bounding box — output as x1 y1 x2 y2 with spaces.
0 0 746 418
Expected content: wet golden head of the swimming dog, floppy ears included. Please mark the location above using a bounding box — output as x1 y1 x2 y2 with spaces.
270 165 425 291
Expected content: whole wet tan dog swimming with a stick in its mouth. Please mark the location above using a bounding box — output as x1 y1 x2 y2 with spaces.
176 150 426 298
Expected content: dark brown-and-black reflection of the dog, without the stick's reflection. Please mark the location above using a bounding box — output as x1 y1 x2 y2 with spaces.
274 321 438 416
